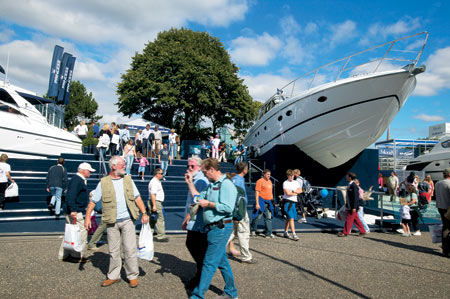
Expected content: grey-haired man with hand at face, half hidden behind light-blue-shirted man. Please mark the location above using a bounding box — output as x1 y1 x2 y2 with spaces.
181 156 209 290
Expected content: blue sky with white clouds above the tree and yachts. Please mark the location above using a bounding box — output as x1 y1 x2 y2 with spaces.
0 0 450 142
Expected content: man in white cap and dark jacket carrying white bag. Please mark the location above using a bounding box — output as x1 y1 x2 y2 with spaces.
58 162 95 262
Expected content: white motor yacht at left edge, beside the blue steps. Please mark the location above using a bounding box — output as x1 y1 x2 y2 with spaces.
0 80 81 158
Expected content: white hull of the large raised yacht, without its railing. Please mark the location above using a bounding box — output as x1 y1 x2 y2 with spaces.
244 70 416 168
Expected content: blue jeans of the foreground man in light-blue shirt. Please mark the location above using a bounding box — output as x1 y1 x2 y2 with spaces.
191 223 237 299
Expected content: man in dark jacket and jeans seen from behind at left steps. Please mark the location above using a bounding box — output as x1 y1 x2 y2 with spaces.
47 158 67 218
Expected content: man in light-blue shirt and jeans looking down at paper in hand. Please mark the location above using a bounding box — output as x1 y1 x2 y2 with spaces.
185 158 237 299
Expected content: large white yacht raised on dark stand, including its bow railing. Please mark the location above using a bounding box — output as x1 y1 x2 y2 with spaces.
244 32 428 168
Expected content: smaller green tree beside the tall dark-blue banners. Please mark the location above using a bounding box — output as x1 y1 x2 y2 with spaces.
64 81 102 128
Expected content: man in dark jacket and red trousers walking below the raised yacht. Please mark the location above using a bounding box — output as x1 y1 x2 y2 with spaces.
338 172 366 237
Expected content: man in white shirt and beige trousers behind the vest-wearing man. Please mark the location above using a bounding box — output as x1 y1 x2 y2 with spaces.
148 168 169 242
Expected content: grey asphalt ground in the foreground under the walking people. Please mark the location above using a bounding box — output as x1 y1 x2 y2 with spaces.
0 232 450 299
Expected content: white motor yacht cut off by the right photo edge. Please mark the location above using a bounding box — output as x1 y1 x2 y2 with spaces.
406 136 450 181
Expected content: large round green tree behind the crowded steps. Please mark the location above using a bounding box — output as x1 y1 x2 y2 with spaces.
117 28 259 139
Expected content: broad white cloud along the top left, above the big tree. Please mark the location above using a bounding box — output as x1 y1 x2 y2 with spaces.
0 0 248 49
